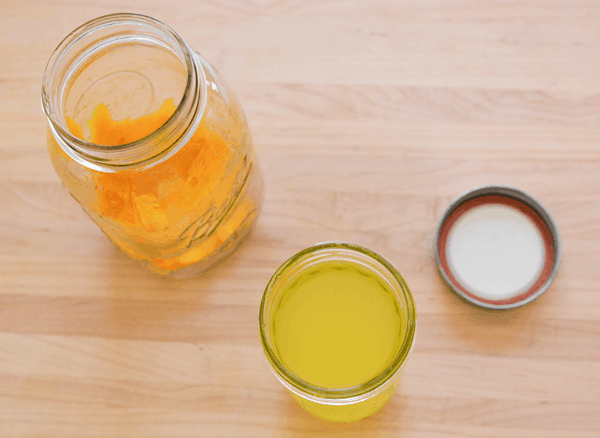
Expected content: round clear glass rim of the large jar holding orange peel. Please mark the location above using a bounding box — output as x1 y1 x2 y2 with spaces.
42 13 206 171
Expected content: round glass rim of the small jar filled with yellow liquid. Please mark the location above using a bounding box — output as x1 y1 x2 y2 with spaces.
259 242 416 404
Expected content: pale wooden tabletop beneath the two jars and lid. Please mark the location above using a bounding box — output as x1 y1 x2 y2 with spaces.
0 0 600 438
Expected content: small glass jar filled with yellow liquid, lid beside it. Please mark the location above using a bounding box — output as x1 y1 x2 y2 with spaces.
259 242 416 422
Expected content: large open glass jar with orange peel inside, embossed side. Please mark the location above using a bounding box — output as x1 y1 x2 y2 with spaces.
42 14 263 278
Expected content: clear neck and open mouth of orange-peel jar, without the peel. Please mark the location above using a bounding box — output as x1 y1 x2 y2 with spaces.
42 14 206 172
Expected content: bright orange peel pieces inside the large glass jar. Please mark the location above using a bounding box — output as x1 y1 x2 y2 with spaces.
67 99 254 271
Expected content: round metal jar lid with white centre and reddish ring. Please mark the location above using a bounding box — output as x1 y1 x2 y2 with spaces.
435 185 561 309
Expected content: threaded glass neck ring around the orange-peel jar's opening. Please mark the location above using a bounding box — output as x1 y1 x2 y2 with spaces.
42 13 206 171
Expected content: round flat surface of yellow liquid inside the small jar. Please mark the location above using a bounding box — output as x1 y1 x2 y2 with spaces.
272 261 404 388
